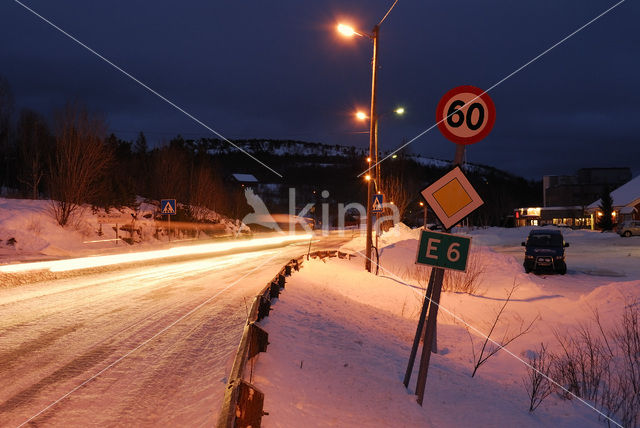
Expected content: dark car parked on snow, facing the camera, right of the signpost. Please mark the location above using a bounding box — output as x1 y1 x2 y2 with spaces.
522 229 569 275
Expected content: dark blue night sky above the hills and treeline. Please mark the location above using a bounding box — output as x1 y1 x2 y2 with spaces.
0 0 640 179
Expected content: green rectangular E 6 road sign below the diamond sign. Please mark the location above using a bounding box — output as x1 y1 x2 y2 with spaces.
416 230 471 272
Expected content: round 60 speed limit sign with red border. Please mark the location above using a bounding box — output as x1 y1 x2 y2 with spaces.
436 85 496 144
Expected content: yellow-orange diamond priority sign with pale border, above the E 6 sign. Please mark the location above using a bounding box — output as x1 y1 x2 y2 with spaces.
422 167 484 229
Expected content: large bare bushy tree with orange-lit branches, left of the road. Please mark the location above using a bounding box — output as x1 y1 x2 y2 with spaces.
49 104 111 226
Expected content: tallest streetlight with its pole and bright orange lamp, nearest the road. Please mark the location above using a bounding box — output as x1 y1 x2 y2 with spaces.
337 0 398 272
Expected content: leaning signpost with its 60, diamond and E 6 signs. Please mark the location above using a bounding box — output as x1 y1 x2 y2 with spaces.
404 86 495 406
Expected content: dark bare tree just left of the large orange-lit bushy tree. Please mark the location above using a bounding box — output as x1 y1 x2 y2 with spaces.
17 110 52 199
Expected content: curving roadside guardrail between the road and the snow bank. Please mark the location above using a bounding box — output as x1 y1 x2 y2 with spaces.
217 250 350 428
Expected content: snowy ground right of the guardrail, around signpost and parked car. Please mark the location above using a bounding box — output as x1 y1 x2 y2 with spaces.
253 227 640 427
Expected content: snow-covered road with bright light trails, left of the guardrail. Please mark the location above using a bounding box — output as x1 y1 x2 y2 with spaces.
0 237 345 426
